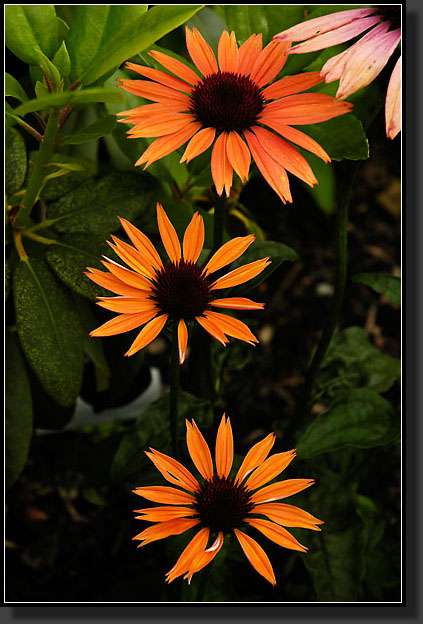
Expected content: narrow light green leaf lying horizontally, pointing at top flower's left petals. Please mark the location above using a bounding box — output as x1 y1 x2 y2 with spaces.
14 87 125 116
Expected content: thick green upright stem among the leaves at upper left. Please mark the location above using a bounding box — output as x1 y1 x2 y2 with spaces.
14 108 59 228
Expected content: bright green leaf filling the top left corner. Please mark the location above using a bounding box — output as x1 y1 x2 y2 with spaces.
5 4 59 65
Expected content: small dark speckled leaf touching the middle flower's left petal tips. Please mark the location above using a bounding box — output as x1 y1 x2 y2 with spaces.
46 234 111 301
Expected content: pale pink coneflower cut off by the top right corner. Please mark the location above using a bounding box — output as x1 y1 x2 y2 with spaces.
274 5 401 139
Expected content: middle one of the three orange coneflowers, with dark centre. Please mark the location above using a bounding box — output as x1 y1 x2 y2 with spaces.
86 203 271 364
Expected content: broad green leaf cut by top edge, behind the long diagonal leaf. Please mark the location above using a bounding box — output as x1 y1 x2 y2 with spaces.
66 5 147 80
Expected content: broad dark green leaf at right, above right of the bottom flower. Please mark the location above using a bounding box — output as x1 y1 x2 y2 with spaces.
297 388 394 459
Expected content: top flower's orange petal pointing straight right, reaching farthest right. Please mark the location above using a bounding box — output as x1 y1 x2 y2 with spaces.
259 93 352 126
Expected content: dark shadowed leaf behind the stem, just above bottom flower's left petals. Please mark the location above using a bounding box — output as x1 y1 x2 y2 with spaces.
110 391 213 485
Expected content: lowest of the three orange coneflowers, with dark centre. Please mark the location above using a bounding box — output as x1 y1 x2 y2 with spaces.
133 415 323 585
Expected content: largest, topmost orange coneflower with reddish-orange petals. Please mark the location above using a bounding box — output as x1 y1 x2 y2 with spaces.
120 28 351 203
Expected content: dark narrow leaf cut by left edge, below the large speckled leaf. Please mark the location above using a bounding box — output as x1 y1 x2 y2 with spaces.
5 331 32 488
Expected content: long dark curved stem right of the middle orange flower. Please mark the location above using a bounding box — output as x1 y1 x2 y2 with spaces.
296 161 359 428
